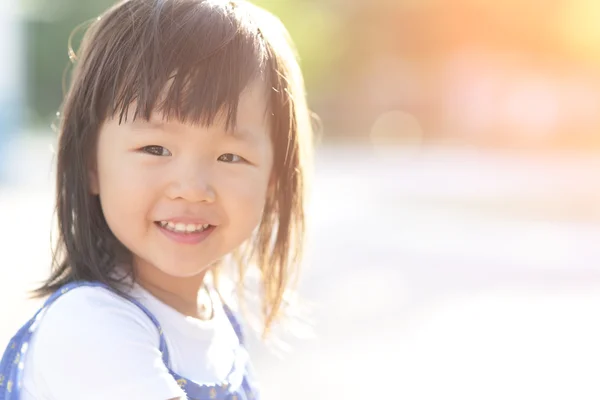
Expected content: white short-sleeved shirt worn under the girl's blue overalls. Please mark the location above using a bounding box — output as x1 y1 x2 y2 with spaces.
22 285 239 400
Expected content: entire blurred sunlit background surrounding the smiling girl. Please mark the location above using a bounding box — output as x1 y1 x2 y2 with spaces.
0 0 600 400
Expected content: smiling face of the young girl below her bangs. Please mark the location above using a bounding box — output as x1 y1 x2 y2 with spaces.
91 80 273 277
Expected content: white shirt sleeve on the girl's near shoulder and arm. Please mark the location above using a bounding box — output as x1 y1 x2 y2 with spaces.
23 287 186 400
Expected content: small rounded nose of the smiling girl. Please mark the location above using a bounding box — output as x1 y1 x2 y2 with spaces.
167 165 216 203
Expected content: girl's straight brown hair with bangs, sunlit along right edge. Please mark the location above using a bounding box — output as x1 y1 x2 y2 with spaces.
36 0 312 332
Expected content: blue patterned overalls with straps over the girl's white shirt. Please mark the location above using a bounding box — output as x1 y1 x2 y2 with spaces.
0 282 259 400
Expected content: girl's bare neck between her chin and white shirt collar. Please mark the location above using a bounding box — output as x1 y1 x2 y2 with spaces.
135 265 212 319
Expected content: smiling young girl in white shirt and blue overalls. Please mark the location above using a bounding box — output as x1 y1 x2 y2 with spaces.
0 0 311 400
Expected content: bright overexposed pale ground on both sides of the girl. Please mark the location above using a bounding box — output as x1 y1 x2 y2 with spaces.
0 139 600 400
